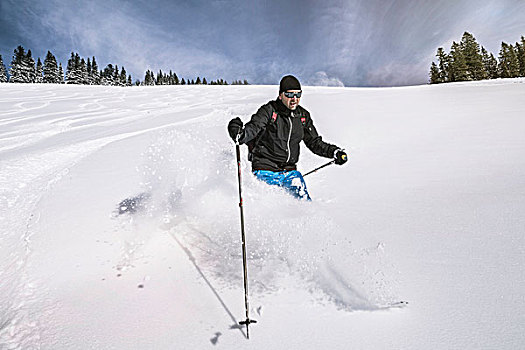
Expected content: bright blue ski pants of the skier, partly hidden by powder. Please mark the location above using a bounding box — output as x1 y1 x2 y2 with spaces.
253 170 312 201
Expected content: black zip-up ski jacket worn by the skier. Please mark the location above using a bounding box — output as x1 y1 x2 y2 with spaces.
239 99 339 171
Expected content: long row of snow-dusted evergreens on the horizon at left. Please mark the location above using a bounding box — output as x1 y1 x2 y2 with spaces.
0 45 248 86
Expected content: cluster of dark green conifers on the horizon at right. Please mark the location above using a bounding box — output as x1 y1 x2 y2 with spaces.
429 32 525 84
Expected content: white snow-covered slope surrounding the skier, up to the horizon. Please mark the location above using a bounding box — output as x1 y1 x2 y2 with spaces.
0 79 525 349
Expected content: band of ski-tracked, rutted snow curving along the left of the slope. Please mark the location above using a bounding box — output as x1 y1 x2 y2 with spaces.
0 87 250 348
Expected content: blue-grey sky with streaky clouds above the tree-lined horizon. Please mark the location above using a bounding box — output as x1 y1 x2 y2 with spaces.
0 0 525 86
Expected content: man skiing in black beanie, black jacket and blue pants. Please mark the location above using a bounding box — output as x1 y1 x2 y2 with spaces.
228 75 347 200
